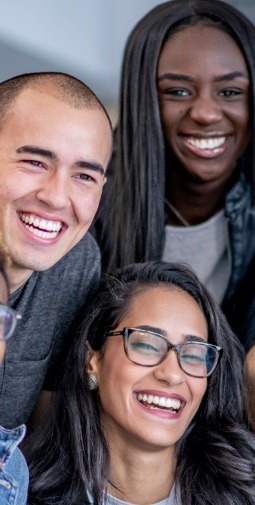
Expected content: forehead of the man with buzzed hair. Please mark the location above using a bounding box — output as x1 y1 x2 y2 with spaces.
0 89 112 164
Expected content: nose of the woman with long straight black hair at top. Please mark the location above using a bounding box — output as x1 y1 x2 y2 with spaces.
189 93 223 126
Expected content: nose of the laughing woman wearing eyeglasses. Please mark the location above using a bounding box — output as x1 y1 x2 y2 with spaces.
154 349 185 387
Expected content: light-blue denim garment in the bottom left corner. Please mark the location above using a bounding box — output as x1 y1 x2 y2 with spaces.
0 425 29 505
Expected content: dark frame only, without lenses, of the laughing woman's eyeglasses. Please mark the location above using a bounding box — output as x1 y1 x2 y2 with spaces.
104 326 223 379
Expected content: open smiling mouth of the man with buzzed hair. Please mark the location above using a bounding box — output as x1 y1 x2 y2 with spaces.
19 212 63 239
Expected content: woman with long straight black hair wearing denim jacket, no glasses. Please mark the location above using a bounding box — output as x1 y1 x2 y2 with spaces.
93 0 255 307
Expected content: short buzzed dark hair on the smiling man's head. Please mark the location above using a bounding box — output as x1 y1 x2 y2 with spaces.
0 72 112 130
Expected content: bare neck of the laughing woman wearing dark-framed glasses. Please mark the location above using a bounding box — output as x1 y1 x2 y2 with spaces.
107 430 175 505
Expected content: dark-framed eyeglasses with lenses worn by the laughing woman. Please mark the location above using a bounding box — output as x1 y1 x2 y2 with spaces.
105 328 222 378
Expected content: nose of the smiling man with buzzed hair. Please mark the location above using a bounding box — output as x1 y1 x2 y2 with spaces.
37 170 70 210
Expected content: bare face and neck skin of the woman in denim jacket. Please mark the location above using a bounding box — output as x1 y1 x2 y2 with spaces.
158 24 250 224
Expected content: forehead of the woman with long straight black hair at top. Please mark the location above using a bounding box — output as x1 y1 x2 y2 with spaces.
159 24 247 73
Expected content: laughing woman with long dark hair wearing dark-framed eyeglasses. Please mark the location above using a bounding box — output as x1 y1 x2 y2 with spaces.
26 261 255 505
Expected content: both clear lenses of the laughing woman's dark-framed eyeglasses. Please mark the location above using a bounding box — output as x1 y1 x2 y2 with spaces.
127 330 218 377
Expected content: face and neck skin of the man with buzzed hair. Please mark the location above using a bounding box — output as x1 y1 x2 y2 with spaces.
0 89 111 291
